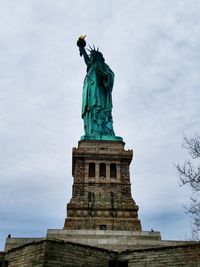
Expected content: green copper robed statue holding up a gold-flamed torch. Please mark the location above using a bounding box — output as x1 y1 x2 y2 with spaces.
77 36 115 139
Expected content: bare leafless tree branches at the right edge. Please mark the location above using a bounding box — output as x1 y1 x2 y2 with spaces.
175 135 200 240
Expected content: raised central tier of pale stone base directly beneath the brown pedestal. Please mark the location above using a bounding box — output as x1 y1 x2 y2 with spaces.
47 229 164 251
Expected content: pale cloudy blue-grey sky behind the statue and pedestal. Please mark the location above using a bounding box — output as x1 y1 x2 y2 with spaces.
0 0 200 250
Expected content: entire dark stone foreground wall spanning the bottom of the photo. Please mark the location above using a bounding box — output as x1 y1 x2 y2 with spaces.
0 239 200 267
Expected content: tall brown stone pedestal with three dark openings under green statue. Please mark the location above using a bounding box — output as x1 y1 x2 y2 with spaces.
64 140 141 231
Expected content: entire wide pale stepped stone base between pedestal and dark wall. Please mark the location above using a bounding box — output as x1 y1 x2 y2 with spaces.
4 229 196 252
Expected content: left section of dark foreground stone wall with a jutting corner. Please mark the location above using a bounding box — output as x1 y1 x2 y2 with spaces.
4 240 114 267
